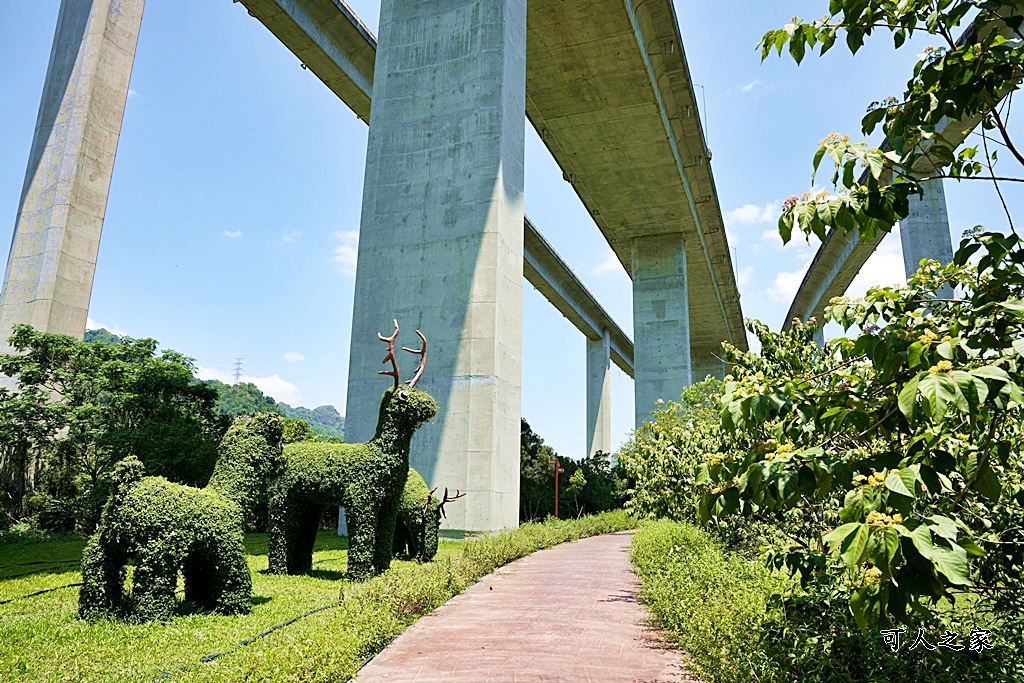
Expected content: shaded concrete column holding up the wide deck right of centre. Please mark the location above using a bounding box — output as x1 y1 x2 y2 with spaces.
633 233 690 427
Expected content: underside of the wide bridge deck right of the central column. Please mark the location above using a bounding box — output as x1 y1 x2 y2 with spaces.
526 0 746 348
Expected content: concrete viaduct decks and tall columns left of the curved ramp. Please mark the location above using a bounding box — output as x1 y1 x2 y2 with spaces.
0 0 746 531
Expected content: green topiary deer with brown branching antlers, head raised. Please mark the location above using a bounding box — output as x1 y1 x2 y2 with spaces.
267 321 437 581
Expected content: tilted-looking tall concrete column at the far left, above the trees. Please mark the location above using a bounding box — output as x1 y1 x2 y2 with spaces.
0 0 145 352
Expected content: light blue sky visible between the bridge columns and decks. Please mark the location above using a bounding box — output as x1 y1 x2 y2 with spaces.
0 0 1021 458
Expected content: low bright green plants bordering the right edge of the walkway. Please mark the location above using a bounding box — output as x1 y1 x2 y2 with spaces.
631 520 1024 683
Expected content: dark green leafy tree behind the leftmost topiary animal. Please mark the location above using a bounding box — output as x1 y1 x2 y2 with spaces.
0 326 227 528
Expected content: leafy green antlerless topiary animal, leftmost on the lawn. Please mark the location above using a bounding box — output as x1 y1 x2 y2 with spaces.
79 414 284 623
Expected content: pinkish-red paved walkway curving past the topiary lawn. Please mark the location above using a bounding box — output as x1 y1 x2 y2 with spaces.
356 532 692 683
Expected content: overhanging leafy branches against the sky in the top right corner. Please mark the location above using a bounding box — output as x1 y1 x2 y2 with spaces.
760 0 1024 242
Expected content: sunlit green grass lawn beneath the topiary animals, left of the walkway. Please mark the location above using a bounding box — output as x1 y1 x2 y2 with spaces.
0 513 633 683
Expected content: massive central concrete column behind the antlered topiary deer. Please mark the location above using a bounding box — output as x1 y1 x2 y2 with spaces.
345 0 526 531
